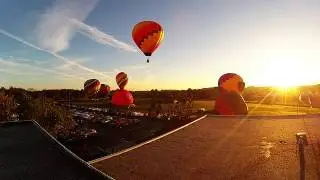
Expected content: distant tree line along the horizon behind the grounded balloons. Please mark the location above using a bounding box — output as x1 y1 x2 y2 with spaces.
0 84 320 104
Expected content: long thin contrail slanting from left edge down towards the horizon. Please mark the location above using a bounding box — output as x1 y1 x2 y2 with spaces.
0 29 111 79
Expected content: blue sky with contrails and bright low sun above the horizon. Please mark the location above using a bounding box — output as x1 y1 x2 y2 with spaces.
0 0 320 90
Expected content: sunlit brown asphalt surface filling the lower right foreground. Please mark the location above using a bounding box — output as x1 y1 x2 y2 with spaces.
93 117 320 180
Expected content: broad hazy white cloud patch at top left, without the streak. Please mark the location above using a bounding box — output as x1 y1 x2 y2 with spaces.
36 0 98 53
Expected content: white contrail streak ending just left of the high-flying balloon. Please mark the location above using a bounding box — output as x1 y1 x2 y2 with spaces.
70 19 137 52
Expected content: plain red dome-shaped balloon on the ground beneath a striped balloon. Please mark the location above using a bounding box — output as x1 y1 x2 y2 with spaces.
112 89 133 106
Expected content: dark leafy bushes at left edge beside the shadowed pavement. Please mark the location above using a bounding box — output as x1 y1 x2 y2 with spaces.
0 87 76 136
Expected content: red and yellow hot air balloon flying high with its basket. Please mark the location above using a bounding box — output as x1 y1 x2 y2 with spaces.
132 21 164 63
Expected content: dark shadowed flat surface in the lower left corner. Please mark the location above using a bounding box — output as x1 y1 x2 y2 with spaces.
0 121 107 180
